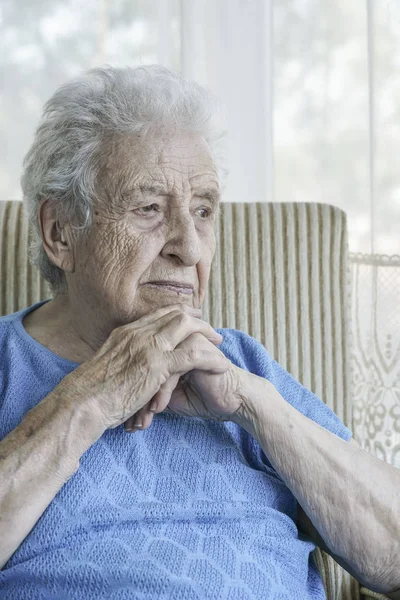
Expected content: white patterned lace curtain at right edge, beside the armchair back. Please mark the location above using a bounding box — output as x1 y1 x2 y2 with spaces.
351 254 400 468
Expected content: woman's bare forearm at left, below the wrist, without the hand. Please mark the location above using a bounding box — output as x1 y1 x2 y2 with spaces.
0 380 103 568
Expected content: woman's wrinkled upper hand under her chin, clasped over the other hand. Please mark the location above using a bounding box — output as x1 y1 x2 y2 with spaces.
62 305 230 429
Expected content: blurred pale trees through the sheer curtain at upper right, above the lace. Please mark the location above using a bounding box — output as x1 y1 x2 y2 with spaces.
273 0 400 254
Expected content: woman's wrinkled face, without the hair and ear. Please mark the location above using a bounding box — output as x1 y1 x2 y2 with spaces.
67 131 219 326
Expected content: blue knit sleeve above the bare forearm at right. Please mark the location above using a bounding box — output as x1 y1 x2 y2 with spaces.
218 329 352 441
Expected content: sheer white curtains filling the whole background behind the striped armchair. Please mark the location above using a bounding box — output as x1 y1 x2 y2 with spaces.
0 0 400 467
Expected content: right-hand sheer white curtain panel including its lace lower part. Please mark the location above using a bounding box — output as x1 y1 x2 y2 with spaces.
272 0 400 467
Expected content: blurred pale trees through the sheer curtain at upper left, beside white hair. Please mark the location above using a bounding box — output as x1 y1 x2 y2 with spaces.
0 0 180 200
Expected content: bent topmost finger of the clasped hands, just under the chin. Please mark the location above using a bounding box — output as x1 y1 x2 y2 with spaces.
157 312 223 350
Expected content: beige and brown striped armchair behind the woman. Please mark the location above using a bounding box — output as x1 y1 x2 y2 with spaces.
0 201 385 600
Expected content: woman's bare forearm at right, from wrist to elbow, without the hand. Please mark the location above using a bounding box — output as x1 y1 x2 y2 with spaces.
234 372 400 597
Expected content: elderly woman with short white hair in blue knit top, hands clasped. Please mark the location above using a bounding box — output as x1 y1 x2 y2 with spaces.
0 67 400 600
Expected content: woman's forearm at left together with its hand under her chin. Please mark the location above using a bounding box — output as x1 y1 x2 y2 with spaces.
0 305 230 568
